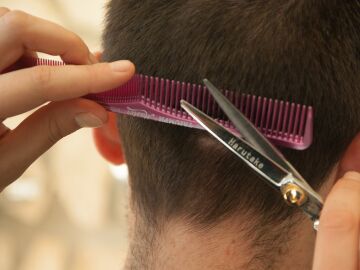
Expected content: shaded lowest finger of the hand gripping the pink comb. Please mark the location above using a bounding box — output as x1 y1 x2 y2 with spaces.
0 99 108 190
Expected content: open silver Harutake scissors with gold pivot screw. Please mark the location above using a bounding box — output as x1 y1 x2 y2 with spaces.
181 79 323 230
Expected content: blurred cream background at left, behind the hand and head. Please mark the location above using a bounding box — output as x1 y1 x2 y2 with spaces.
0 0 128 270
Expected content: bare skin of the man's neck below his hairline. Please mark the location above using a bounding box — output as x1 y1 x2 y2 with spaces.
126 213 315 270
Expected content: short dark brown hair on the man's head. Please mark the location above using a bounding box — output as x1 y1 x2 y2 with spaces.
95 0 360 268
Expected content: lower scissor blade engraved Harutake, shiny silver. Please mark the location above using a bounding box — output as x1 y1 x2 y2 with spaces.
181 100 289 188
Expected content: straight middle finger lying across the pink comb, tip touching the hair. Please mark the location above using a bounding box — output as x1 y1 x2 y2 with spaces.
0 61 135 119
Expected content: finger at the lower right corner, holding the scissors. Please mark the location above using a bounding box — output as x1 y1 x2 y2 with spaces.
313 172 360 270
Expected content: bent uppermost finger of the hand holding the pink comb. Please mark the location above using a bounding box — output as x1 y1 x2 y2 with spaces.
0 8 95 72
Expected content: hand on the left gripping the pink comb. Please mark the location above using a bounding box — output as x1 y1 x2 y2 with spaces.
0 7 135 191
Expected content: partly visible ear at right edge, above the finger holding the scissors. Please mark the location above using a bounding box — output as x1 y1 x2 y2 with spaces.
337 133 360 179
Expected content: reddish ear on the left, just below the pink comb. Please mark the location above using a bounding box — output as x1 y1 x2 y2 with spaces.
93 113 125 165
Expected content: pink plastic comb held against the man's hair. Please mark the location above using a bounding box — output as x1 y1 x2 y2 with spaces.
7 58 313 150
